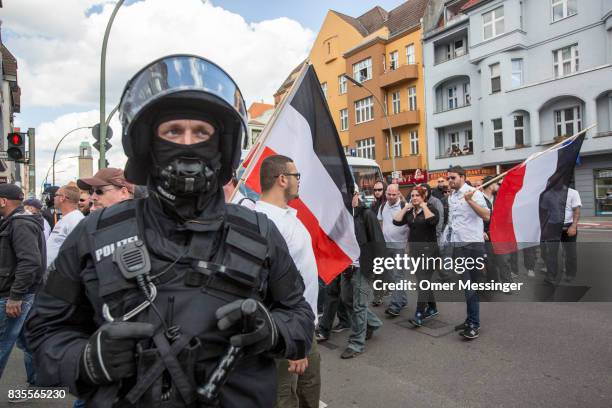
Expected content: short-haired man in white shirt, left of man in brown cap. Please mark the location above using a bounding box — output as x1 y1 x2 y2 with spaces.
47 186 84 267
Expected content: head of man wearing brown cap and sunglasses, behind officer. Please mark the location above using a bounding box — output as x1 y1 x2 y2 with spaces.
77 167 134 211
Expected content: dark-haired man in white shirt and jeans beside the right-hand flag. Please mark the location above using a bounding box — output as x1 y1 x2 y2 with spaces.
445 166 491 340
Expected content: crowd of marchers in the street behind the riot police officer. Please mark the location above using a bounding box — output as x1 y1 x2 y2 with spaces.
0 161 581 407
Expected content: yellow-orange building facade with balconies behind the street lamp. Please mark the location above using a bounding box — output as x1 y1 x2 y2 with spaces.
286 0 427 182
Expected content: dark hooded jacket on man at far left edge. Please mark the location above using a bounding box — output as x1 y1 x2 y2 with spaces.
0 207 47 300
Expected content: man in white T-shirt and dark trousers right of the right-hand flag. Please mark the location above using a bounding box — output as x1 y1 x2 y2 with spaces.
545 188 582 284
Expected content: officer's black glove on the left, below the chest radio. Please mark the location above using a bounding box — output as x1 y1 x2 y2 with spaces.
79 322 155 385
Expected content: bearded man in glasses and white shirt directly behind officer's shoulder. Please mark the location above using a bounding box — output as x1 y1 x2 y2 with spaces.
255 155 321 408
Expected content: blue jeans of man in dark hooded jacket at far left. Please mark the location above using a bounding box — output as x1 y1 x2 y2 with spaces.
0 293 36 384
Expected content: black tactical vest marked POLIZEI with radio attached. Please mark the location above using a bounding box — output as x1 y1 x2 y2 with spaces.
75 200 269 408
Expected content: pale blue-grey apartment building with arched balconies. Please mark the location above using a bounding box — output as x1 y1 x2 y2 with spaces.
423 0 612 215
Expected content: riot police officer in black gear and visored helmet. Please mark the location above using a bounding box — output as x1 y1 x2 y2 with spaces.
27 55 314 408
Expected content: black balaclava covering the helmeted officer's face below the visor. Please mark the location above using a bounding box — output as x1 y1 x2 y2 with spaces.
151 108 222 221
